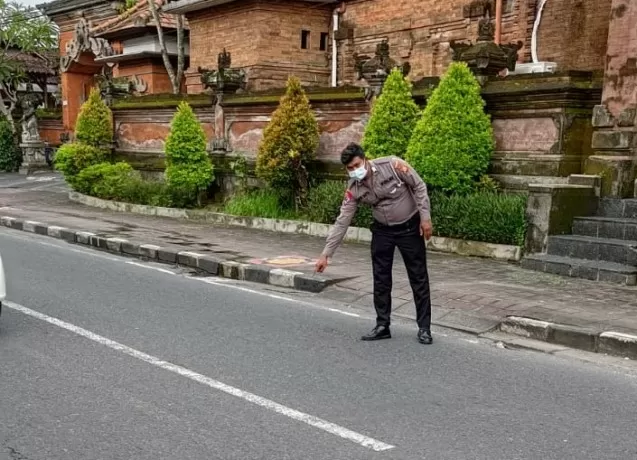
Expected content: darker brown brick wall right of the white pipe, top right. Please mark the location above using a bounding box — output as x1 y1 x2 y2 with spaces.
538 0 612 70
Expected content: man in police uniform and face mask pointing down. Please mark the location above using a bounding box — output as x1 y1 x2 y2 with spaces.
316 143 433 345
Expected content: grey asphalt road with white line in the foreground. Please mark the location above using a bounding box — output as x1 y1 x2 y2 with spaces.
0 229 637 460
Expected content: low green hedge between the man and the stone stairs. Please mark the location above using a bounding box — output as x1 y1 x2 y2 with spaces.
431 192 527 246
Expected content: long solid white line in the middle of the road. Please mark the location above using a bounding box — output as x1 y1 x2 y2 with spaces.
4 302 395 452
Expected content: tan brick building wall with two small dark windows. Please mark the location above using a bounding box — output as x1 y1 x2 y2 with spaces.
188 0 331 93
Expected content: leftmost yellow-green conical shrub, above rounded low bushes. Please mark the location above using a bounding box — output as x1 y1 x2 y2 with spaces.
75 88 113 148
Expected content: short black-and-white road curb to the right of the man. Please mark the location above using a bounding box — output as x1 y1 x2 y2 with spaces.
498 316 637 359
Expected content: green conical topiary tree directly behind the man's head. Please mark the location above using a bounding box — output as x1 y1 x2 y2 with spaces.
362 69 419 158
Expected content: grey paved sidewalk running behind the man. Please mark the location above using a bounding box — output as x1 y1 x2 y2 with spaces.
0 180 637 356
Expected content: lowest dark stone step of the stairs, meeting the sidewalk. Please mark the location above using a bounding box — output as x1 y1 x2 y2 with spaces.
520 254 637 286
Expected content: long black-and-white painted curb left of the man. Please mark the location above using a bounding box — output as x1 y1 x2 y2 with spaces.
0 216 330 293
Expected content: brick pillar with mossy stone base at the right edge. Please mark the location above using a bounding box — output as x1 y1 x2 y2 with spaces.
585 0 637 198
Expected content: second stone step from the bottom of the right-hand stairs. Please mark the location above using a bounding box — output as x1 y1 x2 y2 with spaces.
546 235 637 266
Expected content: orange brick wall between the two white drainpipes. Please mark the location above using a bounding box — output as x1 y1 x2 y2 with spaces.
338 0 531 83
